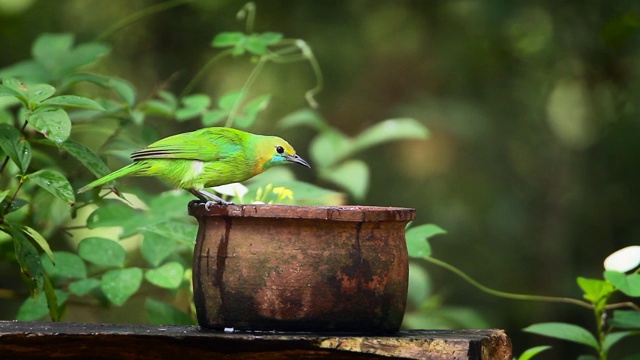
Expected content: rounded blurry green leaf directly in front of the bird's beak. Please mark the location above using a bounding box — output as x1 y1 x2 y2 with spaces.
309 130 353 169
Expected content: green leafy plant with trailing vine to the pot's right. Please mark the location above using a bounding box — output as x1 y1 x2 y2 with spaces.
406 224 640 360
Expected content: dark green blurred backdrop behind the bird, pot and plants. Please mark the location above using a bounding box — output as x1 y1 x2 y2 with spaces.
0 0 640 359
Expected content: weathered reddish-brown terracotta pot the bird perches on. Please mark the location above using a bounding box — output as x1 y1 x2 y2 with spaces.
189 202 415 332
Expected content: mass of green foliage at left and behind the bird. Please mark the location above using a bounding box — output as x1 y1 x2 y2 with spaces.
0 2 426 324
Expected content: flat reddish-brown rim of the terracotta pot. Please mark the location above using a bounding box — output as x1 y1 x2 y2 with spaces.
189 201 416 222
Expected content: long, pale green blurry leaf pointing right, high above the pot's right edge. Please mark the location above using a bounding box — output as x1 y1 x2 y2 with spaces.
354 119 429 151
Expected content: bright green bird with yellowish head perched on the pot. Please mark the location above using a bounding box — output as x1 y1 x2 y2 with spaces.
78 127 311 208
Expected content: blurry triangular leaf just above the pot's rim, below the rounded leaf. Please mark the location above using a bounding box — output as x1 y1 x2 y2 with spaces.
321 160 369 201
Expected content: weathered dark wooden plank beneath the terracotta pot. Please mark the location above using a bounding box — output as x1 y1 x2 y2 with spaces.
0 321 511 360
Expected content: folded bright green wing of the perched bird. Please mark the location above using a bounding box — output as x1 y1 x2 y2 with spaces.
131 128 246 162
